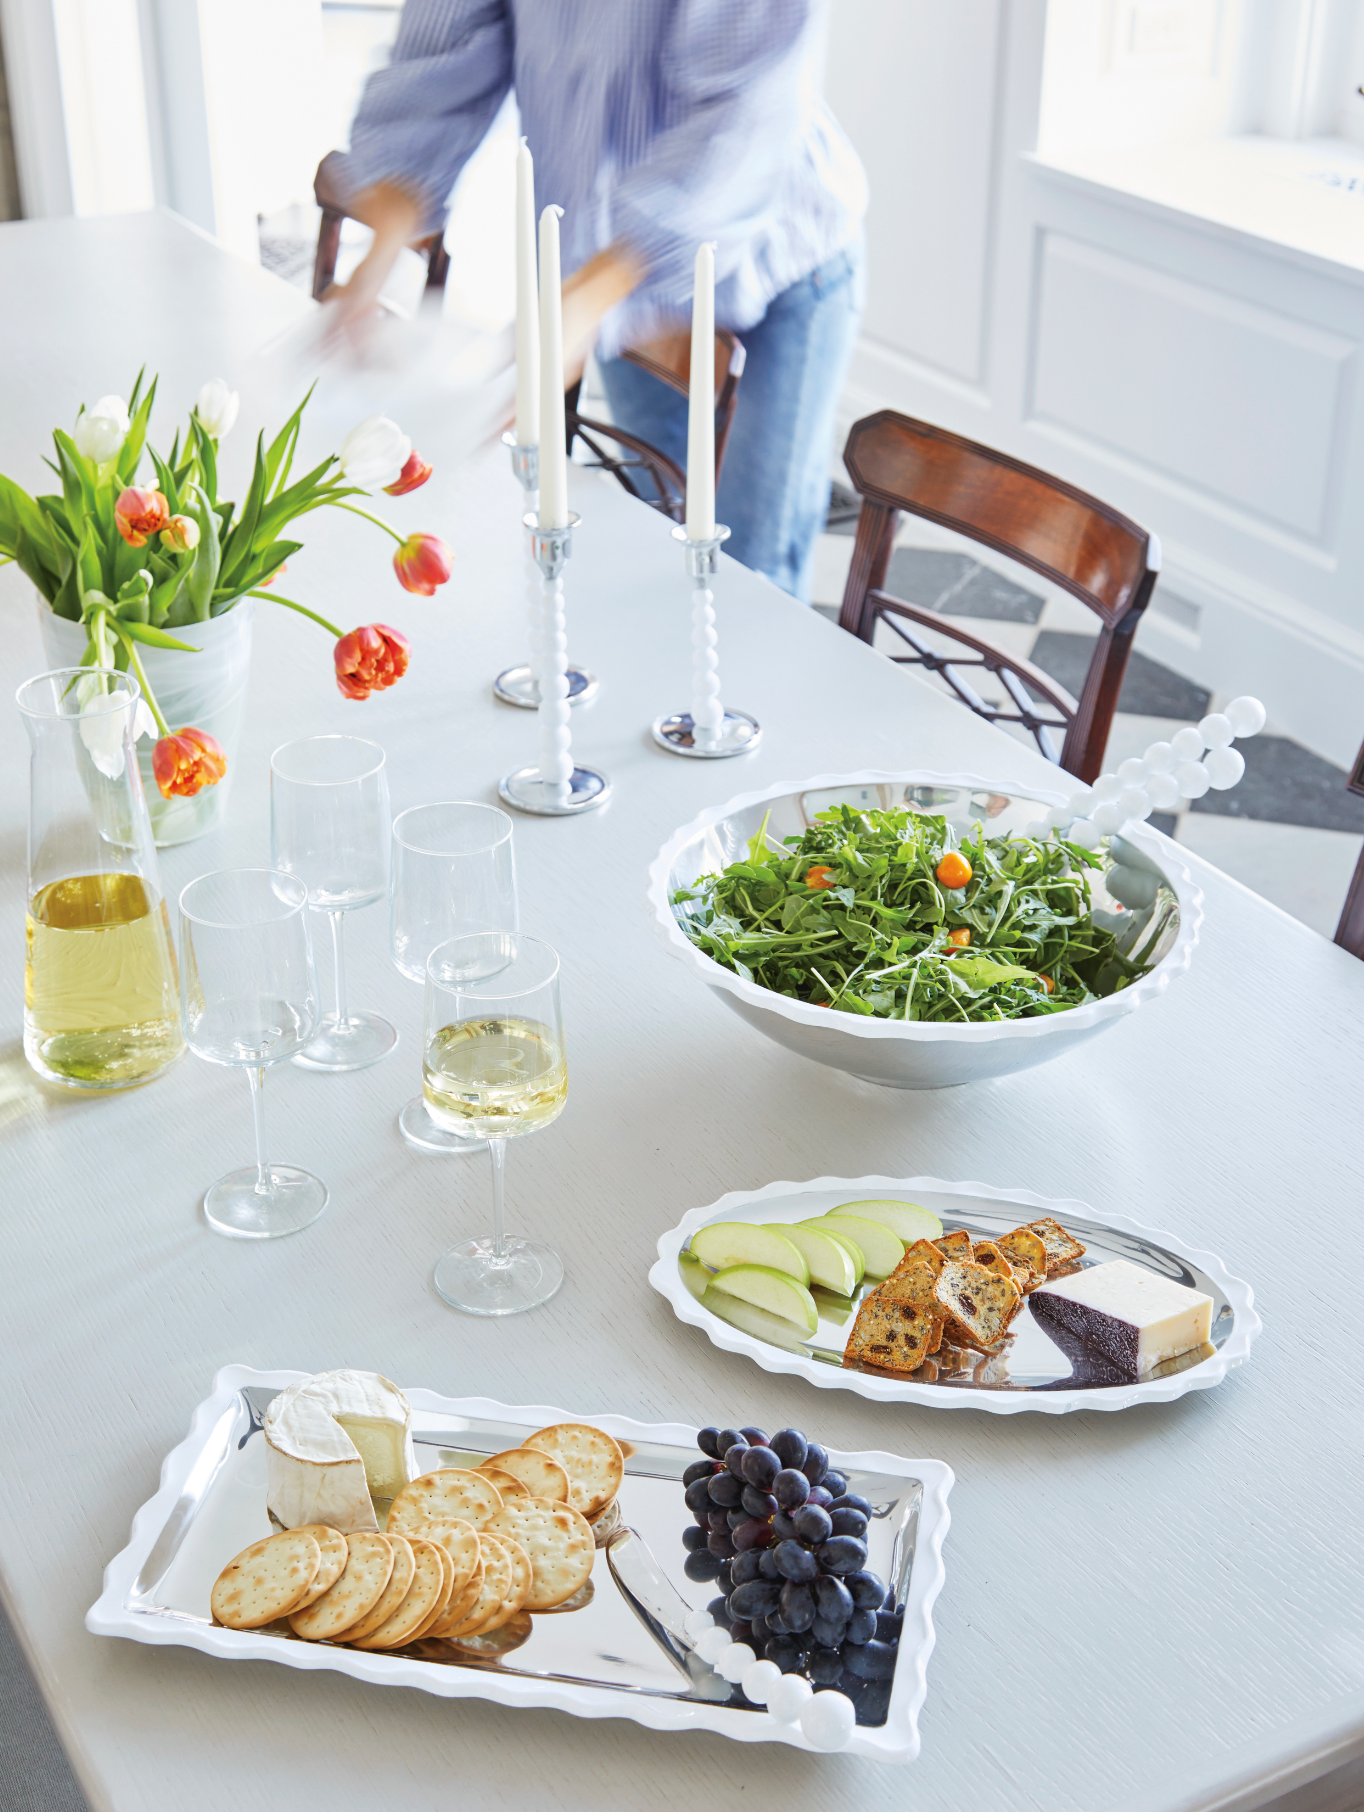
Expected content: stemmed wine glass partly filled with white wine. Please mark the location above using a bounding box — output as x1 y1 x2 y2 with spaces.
431 931 569 1316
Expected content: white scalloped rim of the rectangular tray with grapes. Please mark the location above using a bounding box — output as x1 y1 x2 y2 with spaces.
85 1364 955 1763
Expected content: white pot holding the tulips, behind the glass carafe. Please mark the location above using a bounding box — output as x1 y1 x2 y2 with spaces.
38 598 255 848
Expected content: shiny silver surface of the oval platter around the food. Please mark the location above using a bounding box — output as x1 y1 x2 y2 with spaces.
679 1189 1234 1392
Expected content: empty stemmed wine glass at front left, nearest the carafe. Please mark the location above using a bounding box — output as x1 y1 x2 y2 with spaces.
179 868 326 1239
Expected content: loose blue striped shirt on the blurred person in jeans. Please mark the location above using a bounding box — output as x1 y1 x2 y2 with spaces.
333 0 866 355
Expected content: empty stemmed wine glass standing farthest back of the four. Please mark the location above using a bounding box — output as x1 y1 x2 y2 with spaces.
270 736 399 1071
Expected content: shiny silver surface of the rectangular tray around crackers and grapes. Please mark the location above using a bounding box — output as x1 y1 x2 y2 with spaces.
125 1386 924 1725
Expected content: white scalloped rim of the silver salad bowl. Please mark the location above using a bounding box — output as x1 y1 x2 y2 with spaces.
648 768 1203 1044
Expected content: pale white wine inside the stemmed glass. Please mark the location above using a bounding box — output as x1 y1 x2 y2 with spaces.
422 1018 569 1138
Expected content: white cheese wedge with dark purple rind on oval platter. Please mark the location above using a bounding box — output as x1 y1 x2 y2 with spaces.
1027 1258 1212 1377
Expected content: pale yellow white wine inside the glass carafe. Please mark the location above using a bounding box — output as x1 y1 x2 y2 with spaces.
24 873 183 1089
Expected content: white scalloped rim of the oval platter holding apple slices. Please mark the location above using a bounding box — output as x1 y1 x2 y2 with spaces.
648 1176 1263 1415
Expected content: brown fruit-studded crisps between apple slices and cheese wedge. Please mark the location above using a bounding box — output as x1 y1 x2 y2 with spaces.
844 1218 1085 1375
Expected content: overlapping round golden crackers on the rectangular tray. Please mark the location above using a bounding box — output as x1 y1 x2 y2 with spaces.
212 1422 625 1649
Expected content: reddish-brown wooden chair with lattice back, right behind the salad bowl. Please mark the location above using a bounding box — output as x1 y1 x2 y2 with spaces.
839 410 1161 785
